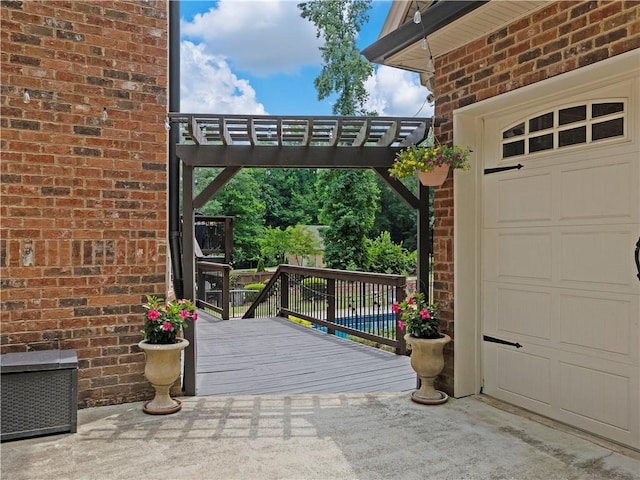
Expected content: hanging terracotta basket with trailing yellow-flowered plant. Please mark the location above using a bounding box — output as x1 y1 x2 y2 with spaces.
389 145 470 186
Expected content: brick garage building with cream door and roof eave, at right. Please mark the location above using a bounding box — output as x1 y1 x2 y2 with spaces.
364 1 640 448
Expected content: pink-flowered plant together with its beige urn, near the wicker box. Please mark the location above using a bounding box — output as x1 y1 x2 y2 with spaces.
138 295 198 415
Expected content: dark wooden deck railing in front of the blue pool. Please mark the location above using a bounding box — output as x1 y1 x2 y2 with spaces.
243 265 406 355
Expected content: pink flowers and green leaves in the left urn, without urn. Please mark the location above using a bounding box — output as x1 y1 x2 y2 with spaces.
141 295 198 345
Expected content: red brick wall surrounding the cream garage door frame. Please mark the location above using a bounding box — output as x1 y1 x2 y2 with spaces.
434 0 640 393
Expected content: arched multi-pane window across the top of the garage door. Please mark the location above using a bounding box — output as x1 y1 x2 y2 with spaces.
502 101 626 158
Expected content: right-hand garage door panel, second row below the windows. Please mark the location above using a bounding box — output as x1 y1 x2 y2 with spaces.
558 225 637 292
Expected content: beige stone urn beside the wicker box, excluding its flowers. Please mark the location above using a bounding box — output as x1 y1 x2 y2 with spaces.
138 338 189 415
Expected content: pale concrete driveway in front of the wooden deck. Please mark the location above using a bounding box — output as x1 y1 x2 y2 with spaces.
1 393 640 480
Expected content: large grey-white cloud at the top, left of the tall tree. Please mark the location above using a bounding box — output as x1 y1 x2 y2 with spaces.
180 0 321 75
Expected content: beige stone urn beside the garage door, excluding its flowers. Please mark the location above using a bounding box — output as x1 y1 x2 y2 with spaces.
404 334 451 405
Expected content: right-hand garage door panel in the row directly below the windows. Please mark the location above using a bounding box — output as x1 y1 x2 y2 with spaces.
558 162 636 223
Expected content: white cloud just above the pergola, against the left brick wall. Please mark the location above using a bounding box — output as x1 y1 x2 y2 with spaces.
180 41 267 115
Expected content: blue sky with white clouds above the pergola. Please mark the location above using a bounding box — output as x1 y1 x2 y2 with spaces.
180 0 432 116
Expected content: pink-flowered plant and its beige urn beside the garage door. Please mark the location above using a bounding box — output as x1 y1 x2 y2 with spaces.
393 293 451 405
